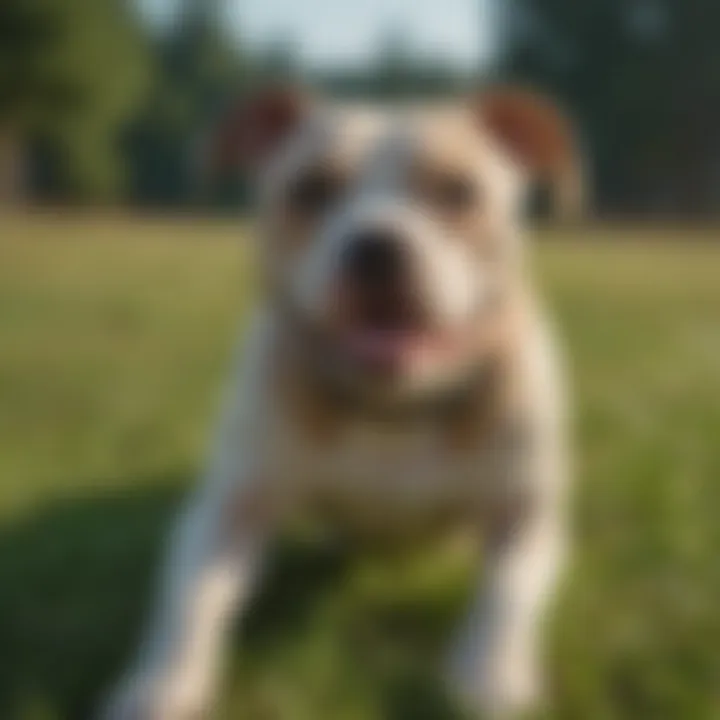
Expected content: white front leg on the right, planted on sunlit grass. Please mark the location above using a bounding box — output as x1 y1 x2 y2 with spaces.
449 484 565 718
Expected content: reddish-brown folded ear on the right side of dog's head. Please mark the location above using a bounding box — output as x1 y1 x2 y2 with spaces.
472 87 585 217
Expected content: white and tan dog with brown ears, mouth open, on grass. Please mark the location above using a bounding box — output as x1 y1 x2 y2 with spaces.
102 88 581 720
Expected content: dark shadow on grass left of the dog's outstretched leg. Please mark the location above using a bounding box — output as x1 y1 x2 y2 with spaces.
0 477 184 720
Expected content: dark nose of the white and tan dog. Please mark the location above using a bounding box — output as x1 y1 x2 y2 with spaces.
343 229 408 288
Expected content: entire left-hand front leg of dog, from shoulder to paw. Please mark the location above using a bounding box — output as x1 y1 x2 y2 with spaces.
101 328 288 720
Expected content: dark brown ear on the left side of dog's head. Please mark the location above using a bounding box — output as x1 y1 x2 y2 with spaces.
204 86 310 178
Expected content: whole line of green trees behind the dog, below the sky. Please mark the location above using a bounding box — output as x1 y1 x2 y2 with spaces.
0 0 720 215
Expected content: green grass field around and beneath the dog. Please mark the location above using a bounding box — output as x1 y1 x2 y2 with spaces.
0 218 720 720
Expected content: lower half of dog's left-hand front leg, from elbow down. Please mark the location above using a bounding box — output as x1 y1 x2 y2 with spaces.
98 472 269 720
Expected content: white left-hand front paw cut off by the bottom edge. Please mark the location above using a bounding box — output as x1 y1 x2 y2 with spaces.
98 675 209 720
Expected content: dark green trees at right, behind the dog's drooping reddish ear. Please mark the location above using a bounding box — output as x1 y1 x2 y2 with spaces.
499 0 720 212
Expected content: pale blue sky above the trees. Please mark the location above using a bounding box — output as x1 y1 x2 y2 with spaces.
137 0 493 68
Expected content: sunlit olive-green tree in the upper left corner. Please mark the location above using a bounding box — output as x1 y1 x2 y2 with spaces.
0 0 150 199
